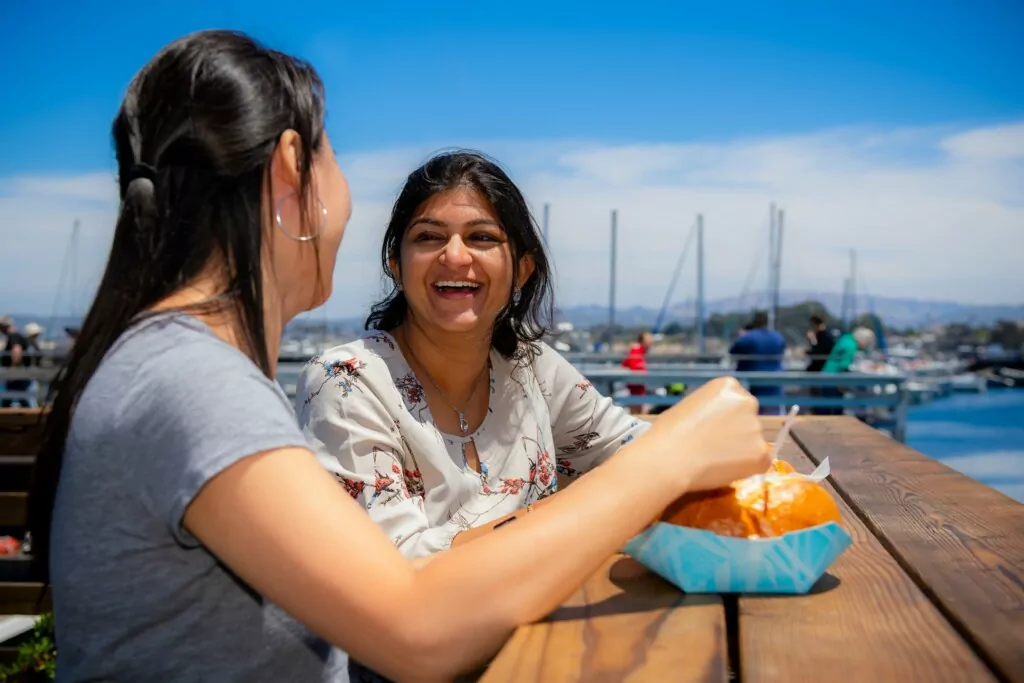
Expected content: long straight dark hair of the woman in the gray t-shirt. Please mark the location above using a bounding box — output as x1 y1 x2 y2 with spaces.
29 31 325 575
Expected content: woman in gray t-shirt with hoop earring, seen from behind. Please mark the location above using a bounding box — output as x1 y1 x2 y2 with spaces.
30 31 767 682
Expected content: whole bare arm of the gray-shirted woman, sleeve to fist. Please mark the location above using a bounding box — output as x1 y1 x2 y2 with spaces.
182 379 769 680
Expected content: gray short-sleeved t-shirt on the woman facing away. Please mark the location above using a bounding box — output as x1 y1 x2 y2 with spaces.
50 314 348 683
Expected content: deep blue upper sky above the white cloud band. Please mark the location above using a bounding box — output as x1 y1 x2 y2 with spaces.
0 0 1024 174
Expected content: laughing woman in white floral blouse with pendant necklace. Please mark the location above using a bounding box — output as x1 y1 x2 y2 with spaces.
296 153 649 557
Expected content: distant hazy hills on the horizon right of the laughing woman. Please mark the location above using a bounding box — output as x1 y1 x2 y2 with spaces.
559 291 1024 328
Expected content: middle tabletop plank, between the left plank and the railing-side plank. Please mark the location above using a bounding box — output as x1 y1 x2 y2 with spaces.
738 418 995 683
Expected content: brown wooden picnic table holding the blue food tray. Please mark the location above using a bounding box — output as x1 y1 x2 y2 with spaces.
479 417 1024 683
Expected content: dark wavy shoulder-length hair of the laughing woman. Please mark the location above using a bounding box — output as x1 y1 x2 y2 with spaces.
366 151 554 358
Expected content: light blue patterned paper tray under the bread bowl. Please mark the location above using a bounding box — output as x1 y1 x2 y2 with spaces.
624 522 852 594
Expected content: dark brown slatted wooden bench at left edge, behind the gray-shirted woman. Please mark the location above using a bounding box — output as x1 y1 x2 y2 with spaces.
0 409 51 663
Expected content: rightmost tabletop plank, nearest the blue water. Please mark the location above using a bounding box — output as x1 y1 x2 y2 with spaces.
794 418 1024 682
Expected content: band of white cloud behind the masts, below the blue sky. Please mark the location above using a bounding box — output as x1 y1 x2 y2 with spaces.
0 123 1024 315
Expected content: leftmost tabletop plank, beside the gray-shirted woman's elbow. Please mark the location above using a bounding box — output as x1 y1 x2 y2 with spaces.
480 555 728 683
